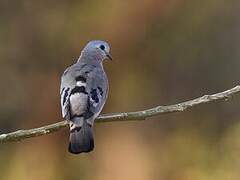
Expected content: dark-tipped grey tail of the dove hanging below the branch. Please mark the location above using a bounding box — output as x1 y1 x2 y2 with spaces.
68 117 94 154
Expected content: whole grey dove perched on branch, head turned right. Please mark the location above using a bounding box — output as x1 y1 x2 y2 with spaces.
60 40 112 154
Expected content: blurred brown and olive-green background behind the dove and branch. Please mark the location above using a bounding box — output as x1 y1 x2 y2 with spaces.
0 0 240 180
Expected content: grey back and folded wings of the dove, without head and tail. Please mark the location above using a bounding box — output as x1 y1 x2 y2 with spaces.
60 64 108 120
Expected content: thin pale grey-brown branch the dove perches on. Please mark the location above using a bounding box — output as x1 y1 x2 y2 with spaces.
0 85 240 143
